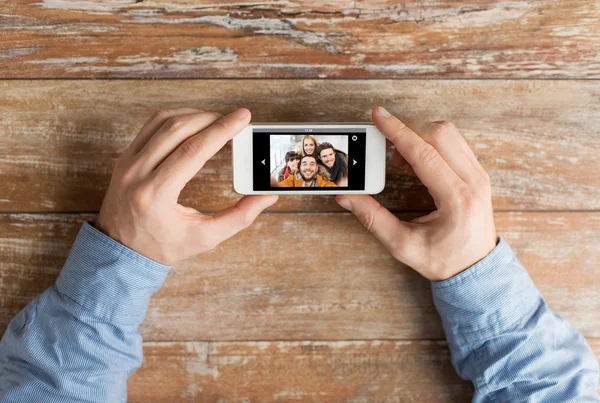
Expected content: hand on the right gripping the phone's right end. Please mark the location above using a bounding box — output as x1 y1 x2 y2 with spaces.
336 107 497 281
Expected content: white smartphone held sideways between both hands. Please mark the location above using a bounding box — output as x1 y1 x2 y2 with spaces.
232 123 386 195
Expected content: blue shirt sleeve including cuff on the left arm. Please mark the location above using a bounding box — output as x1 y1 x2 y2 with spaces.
0 222 169 402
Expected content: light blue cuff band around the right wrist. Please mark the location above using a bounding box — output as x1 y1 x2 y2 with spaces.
431 238 541 347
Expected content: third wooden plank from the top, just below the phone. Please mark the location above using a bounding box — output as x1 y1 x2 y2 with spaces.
0 212 600 341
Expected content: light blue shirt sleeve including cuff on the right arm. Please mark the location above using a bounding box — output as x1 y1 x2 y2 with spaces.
432 238 600 402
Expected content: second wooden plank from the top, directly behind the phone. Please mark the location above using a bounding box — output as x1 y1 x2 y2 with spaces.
0 80 600 211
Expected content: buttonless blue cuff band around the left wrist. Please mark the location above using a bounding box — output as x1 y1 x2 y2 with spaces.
56 221 170 325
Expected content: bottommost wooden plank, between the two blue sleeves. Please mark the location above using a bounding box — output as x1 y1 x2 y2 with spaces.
128 340 473 403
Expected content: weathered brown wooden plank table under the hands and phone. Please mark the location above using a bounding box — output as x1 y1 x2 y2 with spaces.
0 0 600 402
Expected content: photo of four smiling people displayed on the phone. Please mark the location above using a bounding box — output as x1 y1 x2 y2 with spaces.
269 134 348 188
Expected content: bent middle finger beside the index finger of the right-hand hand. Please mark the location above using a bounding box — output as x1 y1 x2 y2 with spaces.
406 121 488 185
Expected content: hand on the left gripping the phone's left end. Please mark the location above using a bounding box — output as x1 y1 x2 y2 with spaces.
96 108 277 265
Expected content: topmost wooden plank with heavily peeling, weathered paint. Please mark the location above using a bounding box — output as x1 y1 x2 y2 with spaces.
0 0 600 78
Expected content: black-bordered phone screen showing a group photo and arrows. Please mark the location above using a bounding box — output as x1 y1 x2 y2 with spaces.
252 128 366 191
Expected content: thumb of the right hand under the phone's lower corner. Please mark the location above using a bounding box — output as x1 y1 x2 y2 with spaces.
335 195 412 263
